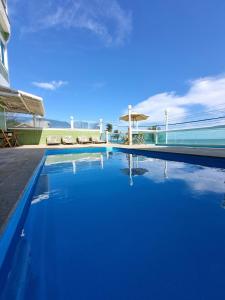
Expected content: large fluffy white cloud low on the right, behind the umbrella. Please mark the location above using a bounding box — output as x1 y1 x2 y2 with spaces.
133 75 225 122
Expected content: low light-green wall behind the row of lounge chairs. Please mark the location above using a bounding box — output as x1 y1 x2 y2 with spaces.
12 129 100 145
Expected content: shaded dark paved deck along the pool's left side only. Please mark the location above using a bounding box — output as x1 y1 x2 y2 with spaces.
0 148 44 234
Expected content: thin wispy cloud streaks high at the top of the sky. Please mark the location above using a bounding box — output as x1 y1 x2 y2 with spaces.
12 0 132 45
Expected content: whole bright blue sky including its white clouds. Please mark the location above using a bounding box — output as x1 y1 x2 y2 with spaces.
8 0 225 123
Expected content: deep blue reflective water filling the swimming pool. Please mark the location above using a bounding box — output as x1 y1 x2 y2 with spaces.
0 150 225 300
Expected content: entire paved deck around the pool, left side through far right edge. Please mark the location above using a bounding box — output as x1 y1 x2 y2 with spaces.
0 144 225 234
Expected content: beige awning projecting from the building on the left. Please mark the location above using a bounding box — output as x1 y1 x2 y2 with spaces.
0 87 45 117
